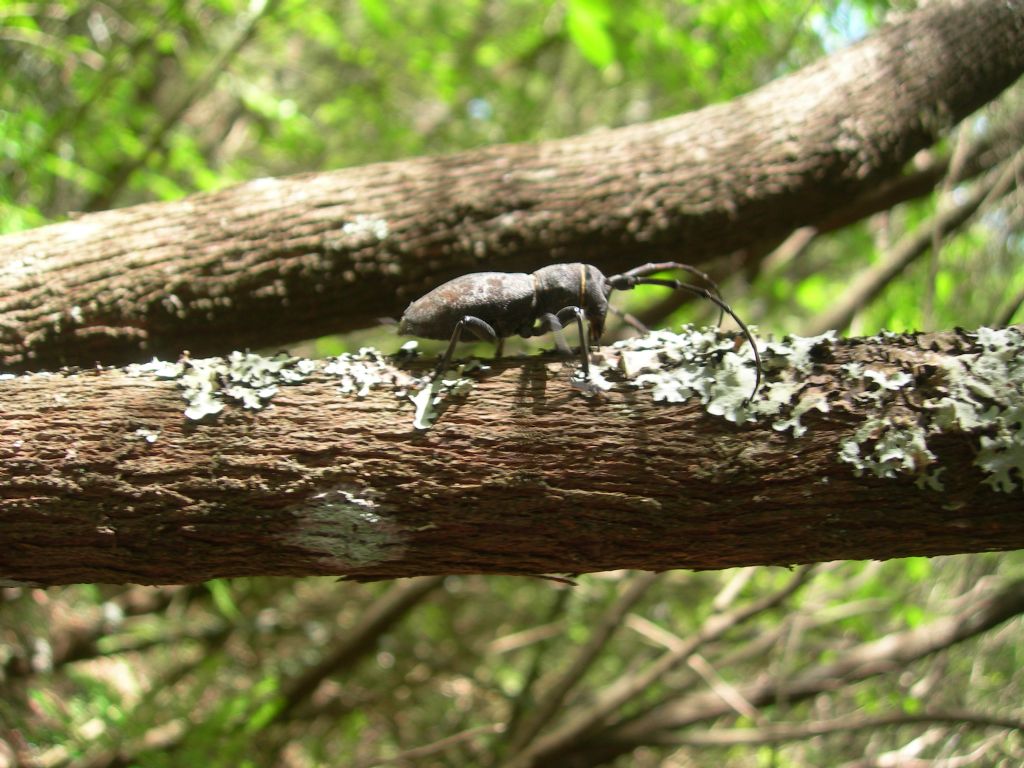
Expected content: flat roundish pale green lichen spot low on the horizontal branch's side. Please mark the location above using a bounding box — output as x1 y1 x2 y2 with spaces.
283 484 406 571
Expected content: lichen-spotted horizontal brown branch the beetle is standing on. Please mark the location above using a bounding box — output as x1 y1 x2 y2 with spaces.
0 329 1024 585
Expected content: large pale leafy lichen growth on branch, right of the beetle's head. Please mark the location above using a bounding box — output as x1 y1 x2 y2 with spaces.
595 327 1024 493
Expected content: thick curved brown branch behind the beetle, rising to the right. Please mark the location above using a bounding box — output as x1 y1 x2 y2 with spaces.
0 0 1024 370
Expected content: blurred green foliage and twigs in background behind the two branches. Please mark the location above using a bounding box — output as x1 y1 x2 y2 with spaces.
0 0 1024 767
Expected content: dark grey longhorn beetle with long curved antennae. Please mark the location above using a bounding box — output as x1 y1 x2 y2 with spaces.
398 261 761 402
